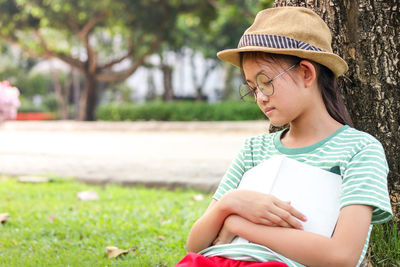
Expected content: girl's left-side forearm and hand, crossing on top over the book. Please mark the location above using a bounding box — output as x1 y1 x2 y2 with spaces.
186 190 306 252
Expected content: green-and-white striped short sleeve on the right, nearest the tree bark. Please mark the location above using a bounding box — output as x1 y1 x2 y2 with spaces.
341 140 393 224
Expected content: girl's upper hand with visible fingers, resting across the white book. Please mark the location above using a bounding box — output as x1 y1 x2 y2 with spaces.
221 189 307 230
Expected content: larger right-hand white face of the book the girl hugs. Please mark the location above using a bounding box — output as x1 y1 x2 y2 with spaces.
271 158 342 237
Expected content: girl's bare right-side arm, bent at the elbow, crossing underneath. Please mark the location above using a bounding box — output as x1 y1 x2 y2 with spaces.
224 205 372 266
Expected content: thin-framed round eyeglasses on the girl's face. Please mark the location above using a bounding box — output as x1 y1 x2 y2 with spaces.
239 62 299 103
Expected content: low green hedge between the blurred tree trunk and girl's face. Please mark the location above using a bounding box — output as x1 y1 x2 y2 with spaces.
97 101 265 121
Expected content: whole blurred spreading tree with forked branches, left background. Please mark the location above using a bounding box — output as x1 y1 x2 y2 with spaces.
0 0 210 120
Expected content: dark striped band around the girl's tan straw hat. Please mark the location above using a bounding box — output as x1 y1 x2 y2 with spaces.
238 34 325 52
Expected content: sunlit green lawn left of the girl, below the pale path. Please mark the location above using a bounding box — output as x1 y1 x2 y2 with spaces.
0 177 210 267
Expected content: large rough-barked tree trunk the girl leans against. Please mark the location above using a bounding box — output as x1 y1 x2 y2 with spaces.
275 0 400 221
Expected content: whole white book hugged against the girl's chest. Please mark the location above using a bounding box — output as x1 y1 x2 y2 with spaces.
232 156 342 244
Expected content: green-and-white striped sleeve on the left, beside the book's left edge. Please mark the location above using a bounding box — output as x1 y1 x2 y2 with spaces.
213 140 248 200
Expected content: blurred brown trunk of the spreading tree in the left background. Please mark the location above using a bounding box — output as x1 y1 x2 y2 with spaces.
78 73 97 121
